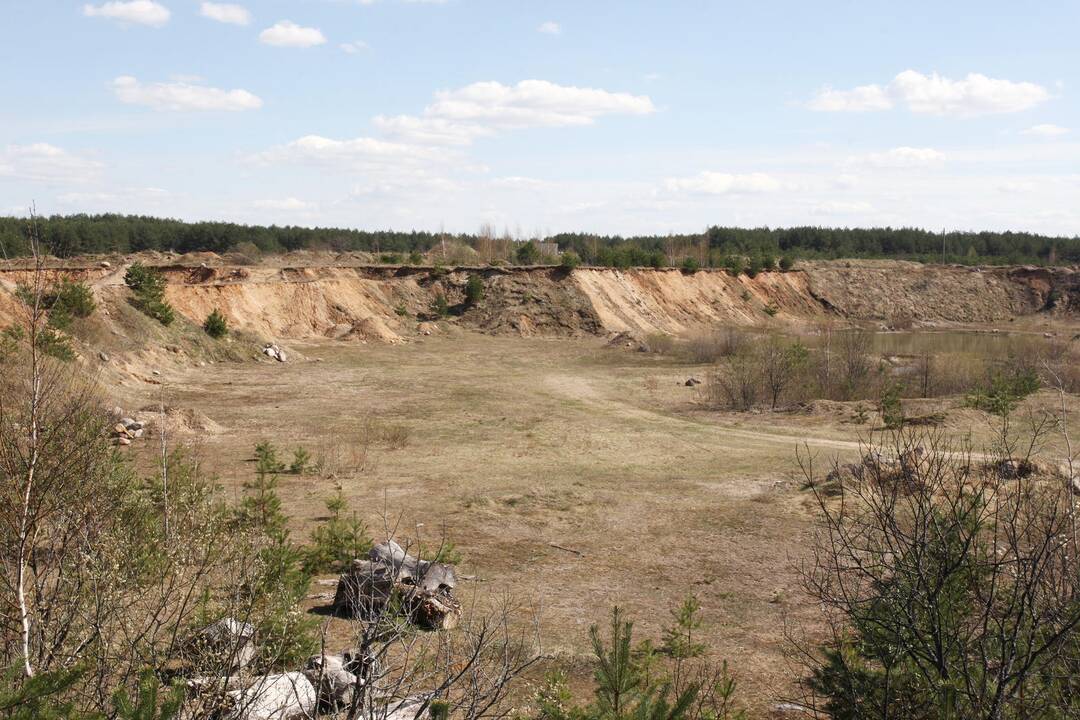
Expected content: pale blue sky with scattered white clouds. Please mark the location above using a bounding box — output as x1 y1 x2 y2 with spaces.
0 0 1080 235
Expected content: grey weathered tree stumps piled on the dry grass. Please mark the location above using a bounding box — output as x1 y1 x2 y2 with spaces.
334 540 461 630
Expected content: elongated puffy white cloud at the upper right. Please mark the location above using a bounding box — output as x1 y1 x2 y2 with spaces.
808 70 1050 117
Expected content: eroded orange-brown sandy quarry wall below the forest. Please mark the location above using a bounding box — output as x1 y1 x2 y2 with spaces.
0 259 1080 342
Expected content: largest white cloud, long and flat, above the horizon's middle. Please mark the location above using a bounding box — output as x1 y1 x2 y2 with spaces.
375 80 656 145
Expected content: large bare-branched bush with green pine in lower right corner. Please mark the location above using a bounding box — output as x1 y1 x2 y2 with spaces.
797 432 1080 720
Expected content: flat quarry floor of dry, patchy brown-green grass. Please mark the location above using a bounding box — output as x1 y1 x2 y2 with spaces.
143 331 1080 717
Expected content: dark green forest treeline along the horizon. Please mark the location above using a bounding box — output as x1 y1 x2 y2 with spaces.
0 215 1080 267
